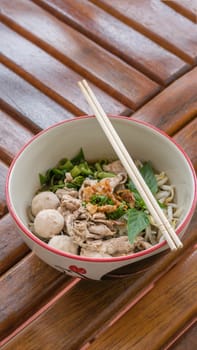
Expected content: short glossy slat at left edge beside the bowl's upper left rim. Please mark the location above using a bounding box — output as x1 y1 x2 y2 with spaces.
0 110 33 163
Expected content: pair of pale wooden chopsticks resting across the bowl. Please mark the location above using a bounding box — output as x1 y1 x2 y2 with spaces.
78 80 183 250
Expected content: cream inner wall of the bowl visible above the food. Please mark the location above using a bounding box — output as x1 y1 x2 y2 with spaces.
8 117 195 239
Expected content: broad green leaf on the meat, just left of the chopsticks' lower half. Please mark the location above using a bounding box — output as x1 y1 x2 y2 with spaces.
127 208 149 244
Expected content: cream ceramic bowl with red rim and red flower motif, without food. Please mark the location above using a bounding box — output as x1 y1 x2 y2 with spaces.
6 116 197 280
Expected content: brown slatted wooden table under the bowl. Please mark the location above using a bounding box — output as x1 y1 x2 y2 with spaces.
0 0 197 350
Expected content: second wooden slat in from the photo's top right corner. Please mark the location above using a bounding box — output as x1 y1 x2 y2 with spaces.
91 0 197 63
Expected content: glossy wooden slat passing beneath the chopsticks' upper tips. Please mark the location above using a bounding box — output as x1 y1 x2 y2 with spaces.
0 24 125 115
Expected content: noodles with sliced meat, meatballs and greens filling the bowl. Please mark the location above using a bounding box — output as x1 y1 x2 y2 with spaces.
29 149 180 258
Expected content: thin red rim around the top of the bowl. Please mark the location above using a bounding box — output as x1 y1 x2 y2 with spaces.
6 114 197 263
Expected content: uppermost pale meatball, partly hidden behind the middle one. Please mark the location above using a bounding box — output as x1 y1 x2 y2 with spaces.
31 191 60 216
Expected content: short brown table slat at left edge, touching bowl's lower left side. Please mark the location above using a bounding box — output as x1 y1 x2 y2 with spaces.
0 214 29 274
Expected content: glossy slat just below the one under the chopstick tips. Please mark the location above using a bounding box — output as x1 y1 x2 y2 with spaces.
0 64 74 131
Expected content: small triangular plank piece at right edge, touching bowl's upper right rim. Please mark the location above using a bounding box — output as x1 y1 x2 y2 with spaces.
174 118 197 172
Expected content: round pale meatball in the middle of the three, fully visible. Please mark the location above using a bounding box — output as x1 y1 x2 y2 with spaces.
34 209 64 238
